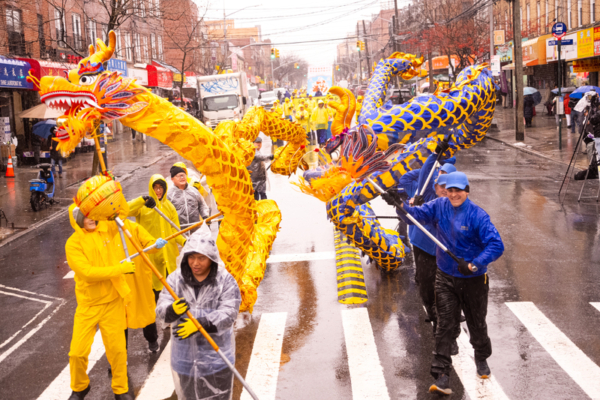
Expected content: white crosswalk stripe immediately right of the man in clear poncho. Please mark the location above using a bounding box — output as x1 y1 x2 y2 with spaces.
240 312 287 400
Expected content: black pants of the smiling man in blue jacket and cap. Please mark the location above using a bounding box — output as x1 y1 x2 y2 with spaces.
431 269 492 378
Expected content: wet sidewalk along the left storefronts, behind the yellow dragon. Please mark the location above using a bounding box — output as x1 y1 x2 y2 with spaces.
0 130 174 245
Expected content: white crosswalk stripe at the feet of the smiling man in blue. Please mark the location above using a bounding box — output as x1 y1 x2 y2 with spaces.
423 307 508 400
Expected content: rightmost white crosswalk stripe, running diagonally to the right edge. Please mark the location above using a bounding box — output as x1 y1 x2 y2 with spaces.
506 301 600 399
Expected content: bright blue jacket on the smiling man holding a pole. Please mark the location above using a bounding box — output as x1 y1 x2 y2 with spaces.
404 197 504 278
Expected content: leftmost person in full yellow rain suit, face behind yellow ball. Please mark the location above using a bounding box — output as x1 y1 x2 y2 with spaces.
65 204 135 400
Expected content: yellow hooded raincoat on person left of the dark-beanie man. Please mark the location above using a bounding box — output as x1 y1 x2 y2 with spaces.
127 174 185 291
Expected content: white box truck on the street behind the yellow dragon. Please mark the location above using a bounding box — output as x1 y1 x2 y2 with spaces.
198 72 252 129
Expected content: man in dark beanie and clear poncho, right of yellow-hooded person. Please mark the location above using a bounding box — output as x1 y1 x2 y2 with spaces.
167 165 209 231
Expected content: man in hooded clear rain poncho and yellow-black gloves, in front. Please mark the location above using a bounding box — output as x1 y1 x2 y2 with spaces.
156 225 241 400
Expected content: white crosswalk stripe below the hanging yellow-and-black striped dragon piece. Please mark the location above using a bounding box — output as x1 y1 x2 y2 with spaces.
342 308 390 400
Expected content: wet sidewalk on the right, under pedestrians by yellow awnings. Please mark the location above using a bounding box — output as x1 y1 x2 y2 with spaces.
486 104 587 170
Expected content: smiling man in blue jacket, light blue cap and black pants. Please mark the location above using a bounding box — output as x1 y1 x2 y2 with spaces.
403 172 504 394
